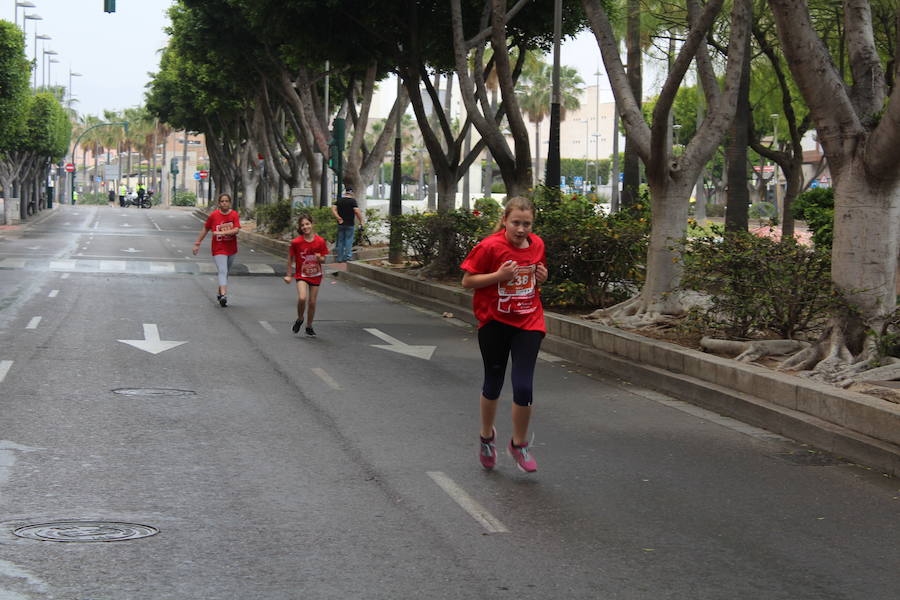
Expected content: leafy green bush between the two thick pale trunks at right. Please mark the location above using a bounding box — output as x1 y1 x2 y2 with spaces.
682 227 837 339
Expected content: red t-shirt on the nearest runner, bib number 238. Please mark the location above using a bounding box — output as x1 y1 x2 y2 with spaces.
461 230 547 333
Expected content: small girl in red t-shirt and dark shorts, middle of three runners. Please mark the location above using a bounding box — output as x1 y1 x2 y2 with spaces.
284 214 328 337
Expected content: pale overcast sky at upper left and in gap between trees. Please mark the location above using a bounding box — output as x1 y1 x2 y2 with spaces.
12 0 612 116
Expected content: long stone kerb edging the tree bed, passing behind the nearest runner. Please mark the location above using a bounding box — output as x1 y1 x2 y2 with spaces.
335 262 900 476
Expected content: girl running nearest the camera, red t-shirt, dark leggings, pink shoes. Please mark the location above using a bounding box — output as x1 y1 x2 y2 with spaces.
461 197 547 473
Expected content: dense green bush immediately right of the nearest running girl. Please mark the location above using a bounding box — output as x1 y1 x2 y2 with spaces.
534 188 650 307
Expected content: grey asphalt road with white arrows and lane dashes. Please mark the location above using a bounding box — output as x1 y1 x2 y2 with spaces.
0 207 900 600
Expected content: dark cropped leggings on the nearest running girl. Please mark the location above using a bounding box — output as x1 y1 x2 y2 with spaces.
478 321 544 406
